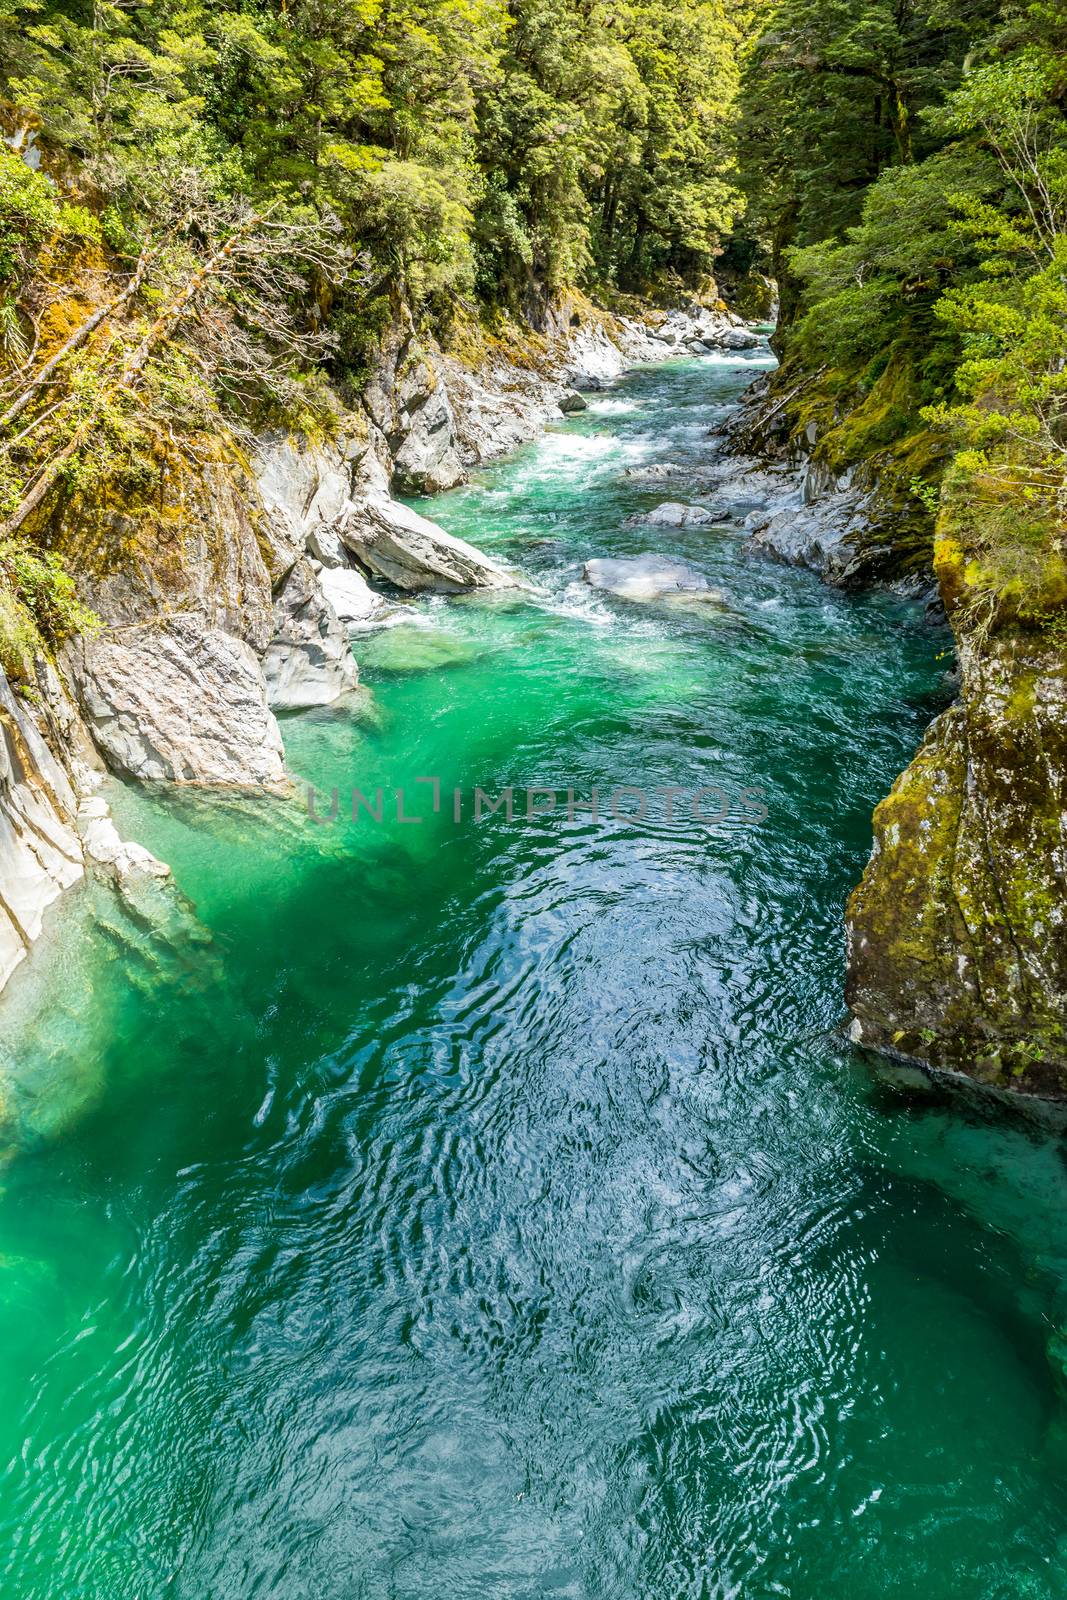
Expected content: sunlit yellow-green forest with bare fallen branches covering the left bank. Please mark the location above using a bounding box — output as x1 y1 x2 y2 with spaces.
0 0 752 669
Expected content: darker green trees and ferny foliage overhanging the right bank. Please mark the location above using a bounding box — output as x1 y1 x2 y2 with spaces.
739 0 1067 630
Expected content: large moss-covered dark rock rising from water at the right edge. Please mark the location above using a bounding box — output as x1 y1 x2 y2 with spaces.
846 617 1067 1098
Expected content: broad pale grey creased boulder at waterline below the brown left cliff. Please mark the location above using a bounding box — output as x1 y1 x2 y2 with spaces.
74 614 286 789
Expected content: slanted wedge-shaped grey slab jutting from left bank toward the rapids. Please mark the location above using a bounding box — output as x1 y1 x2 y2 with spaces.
339 496 520 594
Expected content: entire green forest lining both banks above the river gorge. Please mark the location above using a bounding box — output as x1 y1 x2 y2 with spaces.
0 0 1067 661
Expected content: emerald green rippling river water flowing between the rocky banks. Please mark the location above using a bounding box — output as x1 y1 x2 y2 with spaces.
0 362 1067 1600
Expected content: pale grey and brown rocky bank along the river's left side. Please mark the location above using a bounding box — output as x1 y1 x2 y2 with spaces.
0 291 755 986
